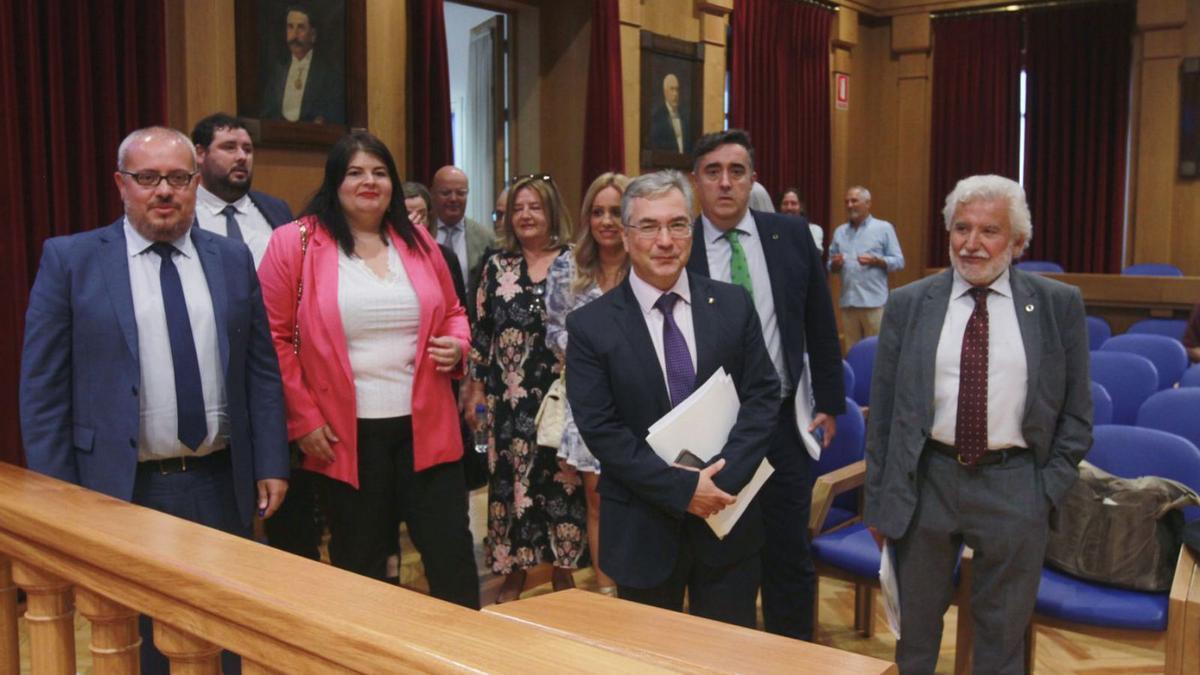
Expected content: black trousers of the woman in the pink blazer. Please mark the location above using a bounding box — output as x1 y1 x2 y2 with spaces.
322 417 479 609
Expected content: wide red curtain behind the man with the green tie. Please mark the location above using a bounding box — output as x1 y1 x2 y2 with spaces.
730 0 833 228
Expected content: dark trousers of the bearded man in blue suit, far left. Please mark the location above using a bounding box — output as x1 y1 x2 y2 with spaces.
133 450 250 675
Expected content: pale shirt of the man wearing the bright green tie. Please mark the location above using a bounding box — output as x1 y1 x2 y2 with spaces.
700 209 793 389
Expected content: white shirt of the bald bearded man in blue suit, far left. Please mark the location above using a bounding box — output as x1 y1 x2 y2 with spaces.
125 219 229 461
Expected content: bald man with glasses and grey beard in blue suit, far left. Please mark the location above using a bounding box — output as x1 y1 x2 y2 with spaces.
20 127 288 671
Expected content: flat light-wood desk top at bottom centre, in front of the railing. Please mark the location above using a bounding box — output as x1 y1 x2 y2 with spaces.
484 589 898 675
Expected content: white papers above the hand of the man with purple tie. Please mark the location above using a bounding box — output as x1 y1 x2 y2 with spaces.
646 368 742 465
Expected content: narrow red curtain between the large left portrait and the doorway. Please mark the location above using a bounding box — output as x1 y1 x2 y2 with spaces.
408 0 454 185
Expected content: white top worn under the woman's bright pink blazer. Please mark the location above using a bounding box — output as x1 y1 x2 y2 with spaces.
337 246 421 419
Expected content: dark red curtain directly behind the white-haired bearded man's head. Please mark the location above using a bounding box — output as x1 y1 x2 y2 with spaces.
928 12 1022 267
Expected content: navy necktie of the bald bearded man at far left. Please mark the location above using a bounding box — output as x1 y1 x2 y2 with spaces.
151 241 209 450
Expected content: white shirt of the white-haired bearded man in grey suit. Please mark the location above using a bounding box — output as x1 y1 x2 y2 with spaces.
931 269 1028 450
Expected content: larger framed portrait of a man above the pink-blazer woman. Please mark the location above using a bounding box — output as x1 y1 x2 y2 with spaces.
235 0 366 149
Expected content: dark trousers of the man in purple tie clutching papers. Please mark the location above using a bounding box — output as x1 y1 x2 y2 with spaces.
617 534 761 628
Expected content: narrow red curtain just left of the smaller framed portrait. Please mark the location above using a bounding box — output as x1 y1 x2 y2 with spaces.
581 0 625 191
